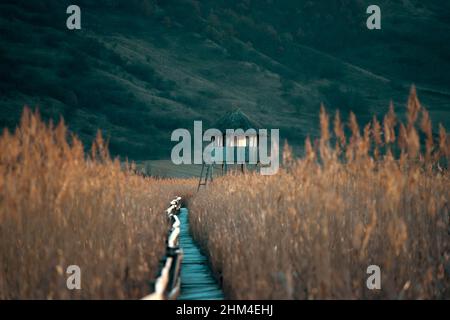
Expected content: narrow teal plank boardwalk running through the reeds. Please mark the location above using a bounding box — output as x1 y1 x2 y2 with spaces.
178 208 224 300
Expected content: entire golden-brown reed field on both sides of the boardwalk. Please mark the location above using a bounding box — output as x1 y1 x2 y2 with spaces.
0 90 450 299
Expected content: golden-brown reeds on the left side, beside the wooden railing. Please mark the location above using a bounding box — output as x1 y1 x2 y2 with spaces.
0 109 191 299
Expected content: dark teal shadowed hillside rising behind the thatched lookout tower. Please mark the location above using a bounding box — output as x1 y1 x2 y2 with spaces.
0 0 450 160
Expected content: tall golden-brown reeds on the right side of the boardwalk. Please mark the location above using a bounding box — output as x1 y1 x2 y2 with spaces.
190 90 450 299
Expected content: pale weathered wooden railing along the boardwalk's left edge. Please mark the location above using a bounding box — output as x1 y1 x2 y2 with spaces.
142 197 183 300
